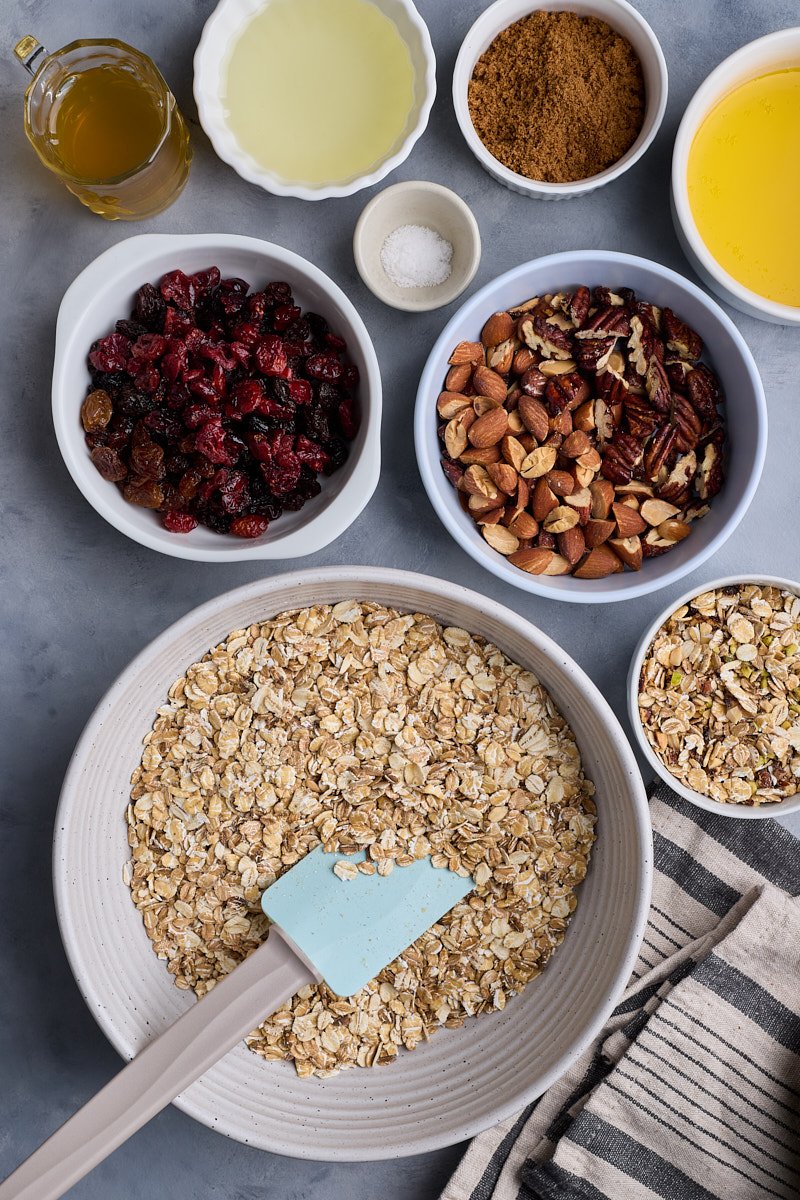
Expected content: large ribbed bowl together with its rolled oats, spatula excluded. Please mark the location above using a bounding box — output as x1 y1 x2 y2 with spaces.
54 566 651 1160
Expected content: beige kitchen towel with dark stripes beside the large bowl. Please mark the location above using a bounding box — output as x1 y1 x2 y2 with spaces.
441 784 800 1200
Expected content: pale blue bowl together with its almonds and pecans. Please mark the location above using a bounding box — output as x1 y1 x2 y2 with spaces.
415 251 766 604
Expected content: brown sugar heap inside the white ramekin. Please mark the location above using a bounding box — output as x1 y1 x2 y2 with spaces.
468 12 644 184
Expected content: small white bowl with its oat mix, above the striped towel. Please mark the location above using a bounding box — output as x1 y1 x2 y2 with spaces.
627 575 800 817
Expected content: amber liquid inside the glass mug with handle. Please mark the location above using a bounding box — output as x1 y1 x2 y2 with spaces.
52 66 163 180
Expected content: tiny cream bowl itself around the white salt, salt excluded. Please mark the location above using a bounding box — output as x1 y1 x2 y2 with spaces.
353 180 481 312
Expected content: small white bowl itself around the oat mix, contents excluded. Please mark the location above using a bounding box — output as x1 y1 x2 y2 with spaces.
627 575 800 820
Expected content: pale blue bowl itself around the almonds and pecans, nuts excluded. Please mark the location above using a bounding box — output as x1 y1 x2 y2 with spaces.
414 250 766 604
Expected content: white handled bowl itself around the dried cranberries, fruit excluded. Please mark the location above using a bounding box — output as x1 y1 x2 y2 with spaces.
53 234 380 563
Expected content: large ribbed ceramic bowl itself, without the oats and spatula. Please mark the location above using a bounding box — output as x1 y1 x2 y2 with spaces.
54 566 651 1160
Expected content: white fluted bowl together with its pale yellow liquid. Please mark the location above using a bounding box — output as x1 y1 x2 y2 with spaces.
194 0 435 200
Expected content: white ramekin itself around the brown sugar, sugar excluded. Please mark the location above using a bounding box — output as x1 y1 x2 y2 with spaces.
453 0 667 200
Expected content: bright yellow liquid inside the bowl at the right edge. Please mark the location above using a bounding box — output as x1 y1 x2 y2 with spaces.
687 66 800 306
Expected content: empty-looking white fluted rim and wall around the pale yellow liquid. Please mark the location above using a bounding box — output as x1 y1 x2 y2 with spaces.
194 0 437 200
